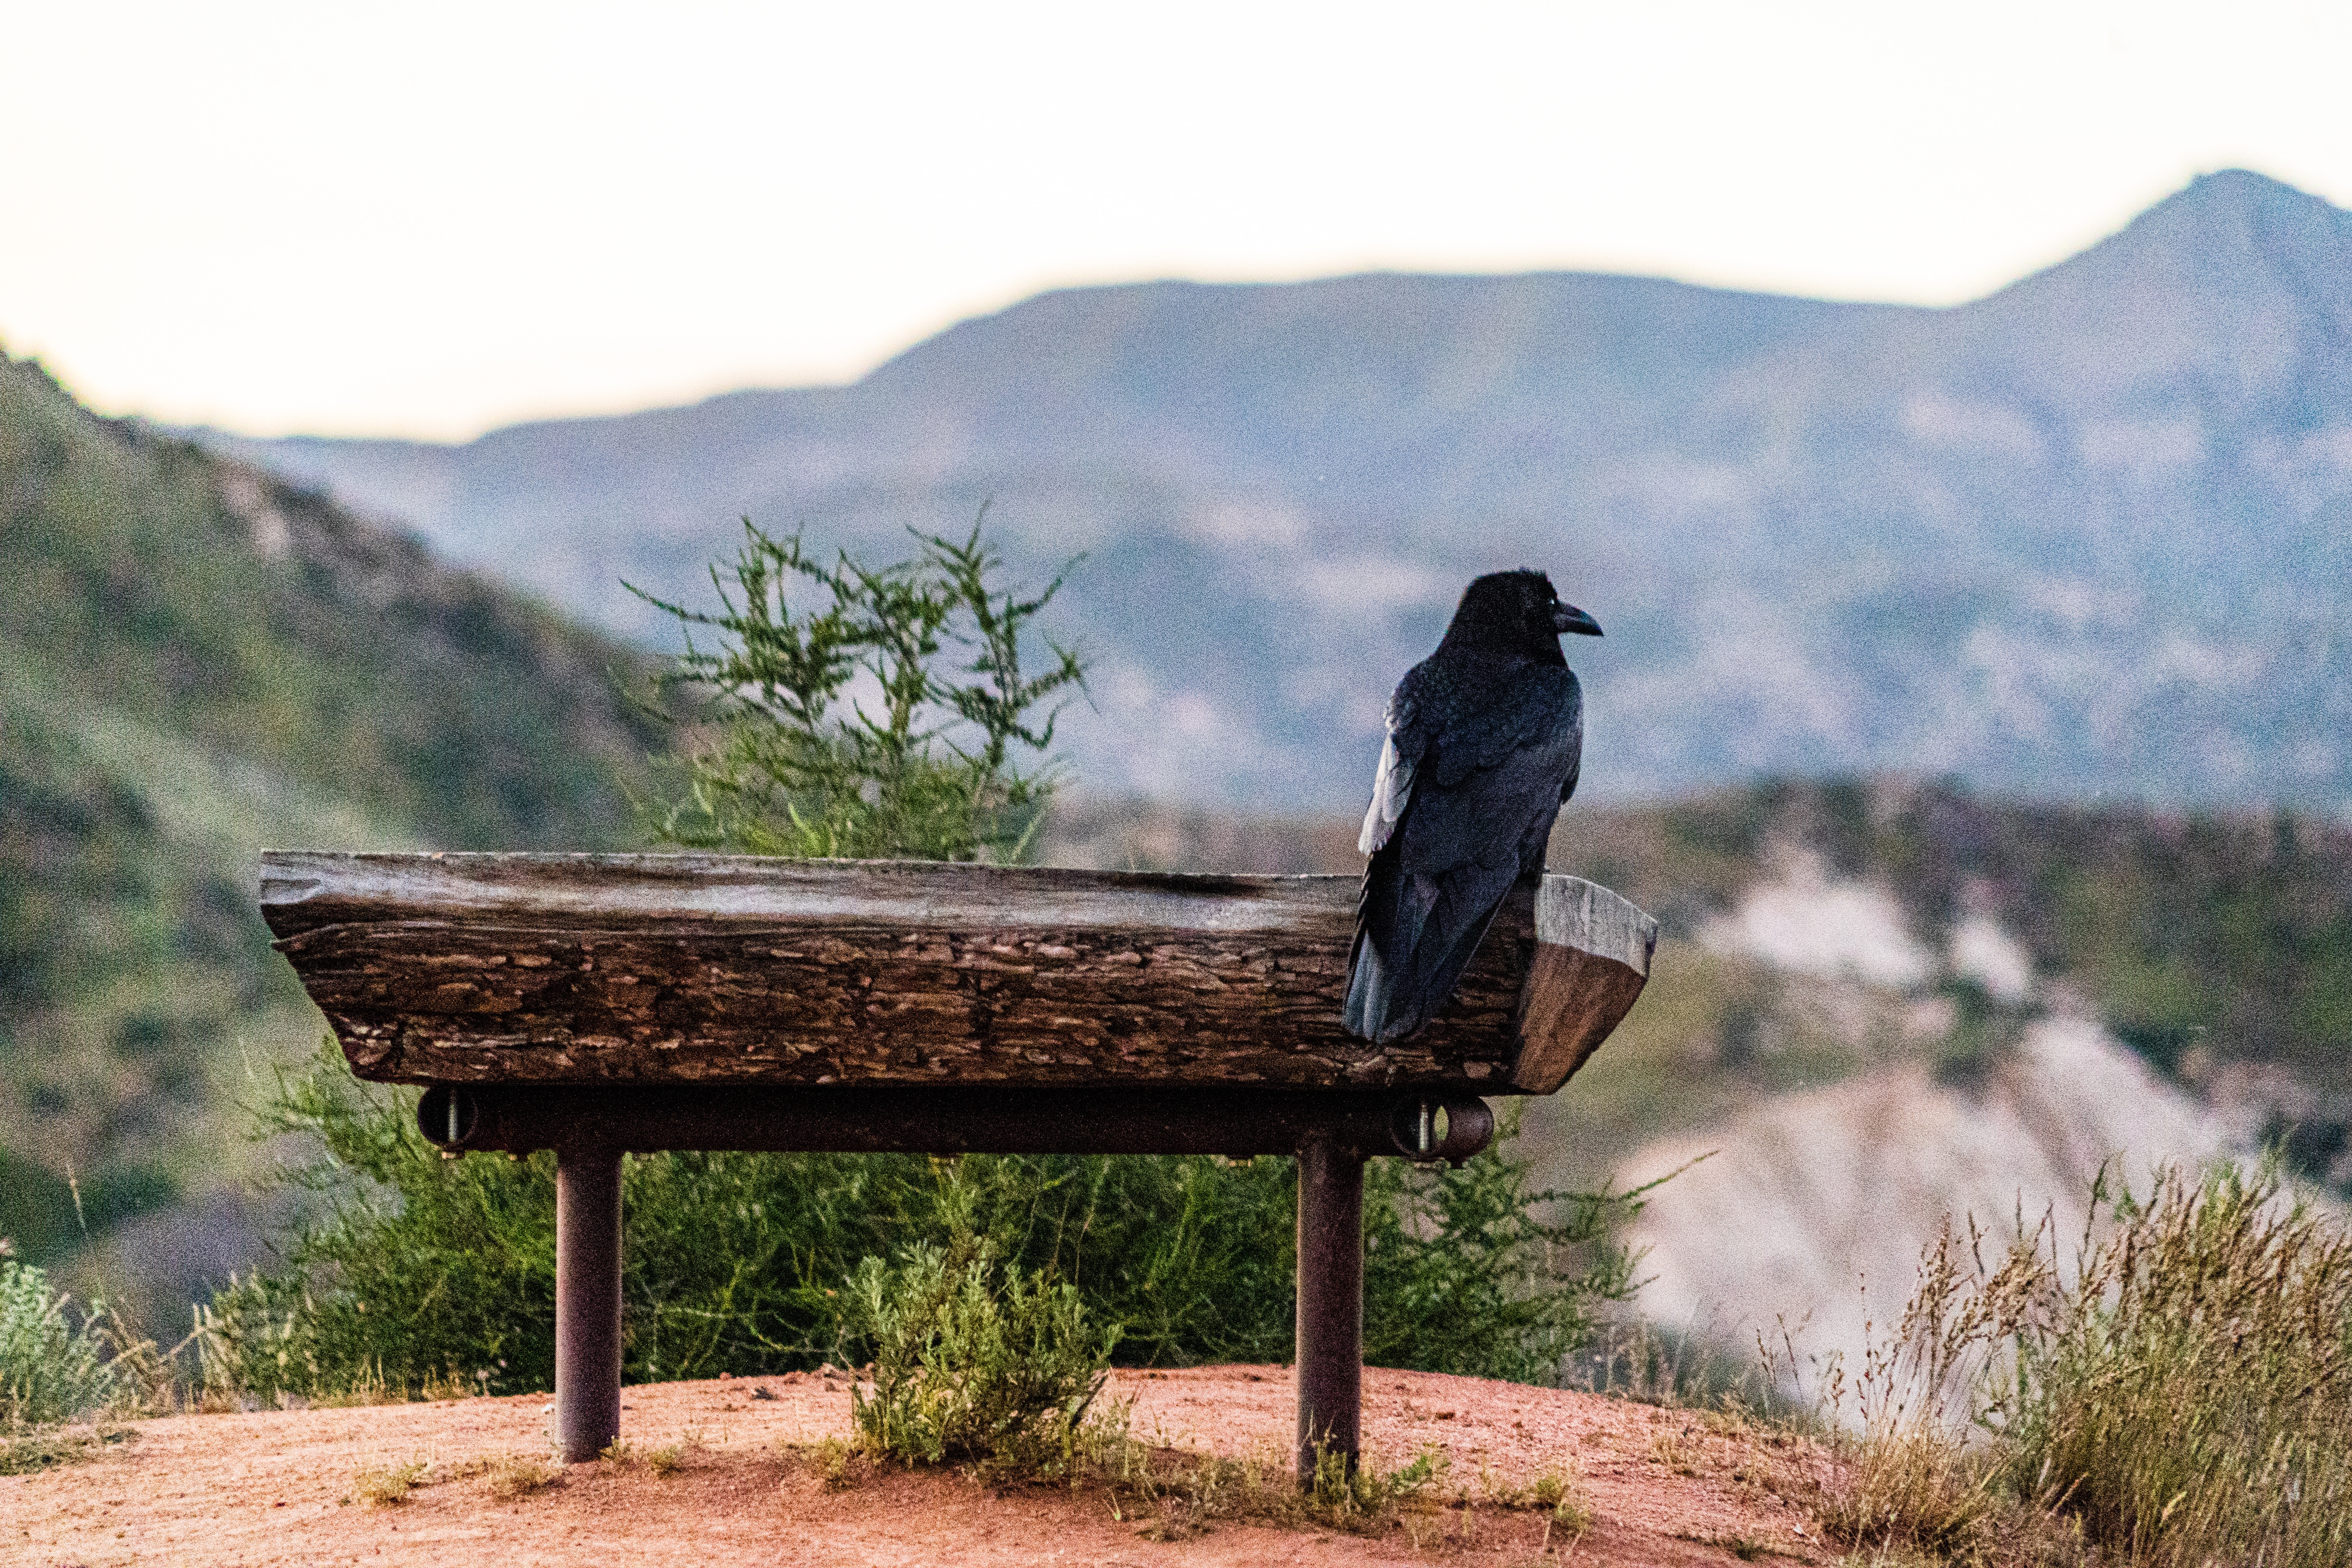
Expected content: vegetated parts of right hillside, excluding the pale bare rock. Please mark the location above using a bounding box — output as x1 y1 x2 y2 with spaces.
1536 778 2352 1196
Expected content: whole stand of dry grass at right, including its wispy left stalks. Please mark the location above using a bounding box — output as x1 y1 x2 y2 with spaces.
1788 1166 2352 1568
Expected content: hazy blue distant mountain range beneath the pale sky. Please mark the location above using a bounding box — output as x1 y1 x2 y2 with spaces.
209 172 2352 813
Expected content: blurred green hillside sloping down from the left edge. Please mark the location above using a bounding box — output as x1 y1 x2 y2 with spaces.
0 355 652 1258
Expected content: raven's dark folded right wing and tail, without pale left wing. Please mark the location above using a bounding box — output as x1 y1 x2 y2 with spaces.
1343 665 1583 1042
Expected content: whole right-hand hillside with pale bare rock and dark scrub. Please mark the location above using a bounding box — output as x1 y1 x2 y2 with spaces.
1529 780 2352 1366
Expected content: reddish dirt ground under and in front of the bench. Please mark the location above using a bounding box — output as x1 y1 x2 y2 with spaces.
0 1366 1825 1568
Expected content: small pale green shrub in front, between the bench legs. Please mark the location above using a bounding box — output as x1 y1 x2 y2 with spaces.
847 1232 1120 1474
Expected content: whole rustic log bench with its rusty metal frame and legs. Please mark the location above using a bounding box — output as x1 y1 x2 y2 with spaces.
261 851 1658 1474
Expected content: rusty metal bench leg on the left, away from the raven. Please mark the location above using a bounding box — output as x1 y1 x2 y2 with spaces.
555 1150 621 1465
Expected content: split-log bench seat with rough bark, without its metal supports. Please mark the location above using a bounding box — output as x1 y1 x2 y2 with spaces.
261 851 1656 1093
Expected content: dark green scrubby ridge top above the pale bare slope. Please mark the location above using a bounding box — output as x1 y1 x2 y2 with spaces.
1571 780 2352 1086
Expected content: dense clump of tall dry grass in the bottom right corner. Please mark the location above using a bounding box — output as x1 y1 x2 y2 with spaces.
1980 1166 2352 1568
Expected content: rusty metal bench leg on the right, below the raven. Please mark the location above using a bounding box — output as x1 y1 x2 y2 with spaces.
1298 1138 1364 1488
